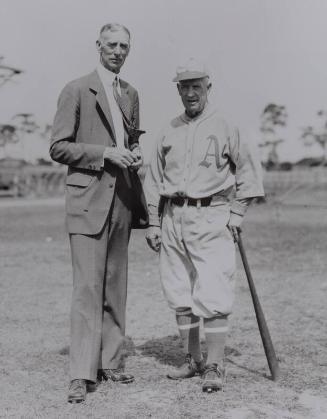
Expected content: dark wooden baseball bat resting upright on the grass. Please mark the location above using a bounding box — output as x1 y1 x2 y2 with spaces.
237 229 279 381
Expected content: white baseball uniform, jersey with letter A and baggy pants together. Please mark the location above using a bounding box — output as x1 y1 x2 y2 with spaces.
144 105 264 318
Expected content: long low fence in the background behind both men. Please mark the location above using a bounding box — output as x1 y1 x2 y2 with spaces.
0 166 327 207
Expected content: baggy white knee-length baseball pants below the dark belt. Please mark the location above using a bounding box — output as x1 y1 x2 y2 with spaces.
160 201 236 318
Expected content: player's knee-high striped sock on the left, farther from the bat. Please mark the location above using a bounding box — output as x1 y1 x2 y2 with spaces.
176 309 202 361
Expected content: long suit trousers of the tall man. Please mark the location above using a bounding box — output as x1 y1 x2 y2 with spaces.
70 171 132 381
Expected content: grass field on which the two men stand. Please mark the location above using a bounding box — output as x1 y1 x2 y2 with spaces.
0 201 327 419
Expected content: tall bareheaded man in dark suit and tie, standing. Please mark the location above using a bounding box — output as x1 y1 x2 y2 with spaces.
50 24 147 403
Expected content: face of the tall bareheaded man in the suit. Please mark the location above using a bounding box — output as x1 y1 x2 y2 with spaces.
97 29 129 74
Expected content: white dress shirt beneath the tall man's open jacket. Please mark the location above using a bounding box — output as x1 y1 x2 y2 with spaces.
97 64 125 147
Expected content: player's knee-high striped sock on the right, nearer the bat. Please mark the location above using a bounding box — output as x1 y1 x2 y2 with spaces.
204 316 228 364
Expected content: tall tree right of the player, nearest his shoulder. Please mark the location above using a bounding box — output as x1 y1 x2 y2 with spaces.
259 103 287 168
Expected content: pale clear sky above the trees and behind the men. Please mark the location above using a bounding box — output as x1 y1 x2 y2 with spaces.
0 0 327 161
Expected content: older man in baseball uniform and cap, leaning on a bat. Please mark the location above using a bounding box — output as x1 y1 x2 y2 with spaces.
144 59 264 392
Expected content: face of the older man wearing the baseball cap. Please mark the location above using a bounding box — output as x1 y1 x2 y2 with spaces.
177 78 210 118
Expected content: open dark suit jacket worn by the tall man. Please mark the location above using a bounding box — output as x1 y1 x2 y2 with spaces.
50 71 148 234
